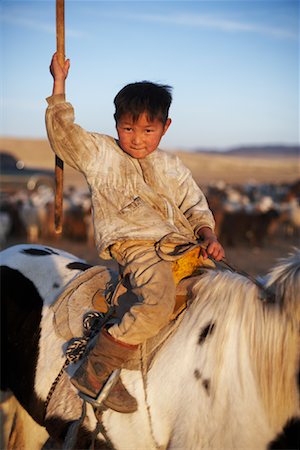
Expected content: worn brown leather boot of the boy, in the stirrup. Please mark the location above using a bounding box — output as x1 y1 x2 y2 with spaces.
70 330 138 413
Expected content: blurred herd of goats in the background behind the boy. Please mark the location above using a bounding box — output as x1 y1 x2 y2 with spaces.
0 180 300 247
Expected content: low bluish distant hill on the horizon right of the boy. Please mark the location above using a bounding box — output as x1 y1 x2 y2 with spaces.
196 145 300 158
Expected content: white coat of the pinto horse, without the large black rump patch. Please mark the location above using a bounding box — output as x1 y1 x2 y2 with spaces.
1 245 300 450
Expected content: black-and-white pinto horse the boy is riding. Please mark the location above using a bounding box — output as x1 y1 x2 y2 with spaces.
1 244 300 450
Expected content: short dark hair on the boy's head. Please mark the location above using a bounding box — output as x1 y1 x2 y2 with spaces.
114 81 172 124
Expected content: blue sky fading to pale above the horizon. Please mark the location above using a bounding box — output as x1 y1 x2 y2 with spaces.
0 0 299 151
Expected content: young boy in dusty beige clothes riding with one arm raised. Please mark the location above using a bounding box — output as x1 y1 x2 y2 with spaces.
46 54 224 413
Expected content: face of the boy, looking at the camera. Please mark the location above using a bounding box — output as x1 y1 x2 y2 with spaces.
117 113 171 159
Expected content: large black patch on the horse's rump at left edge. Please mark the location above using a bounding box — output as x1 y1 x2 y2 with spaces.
1 266 44 424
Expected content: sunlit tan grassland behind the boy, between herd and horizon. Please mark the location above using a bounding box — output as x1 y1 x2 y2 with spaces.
0 138 300 187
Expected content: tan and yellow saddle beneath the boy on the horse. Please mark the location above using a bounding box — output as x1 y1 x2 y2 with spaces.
51 247 215 341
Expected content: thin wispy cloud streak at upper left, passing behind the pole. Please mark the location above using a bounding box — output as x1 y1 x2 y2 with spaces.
0 13 84 38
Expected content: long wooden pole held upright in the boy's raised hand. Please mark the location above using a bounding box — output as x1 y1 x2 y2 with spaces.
54 0 65 234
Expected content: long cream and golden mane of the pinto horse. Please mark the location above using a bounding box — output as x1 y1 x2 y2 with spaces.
184 260 300 428
